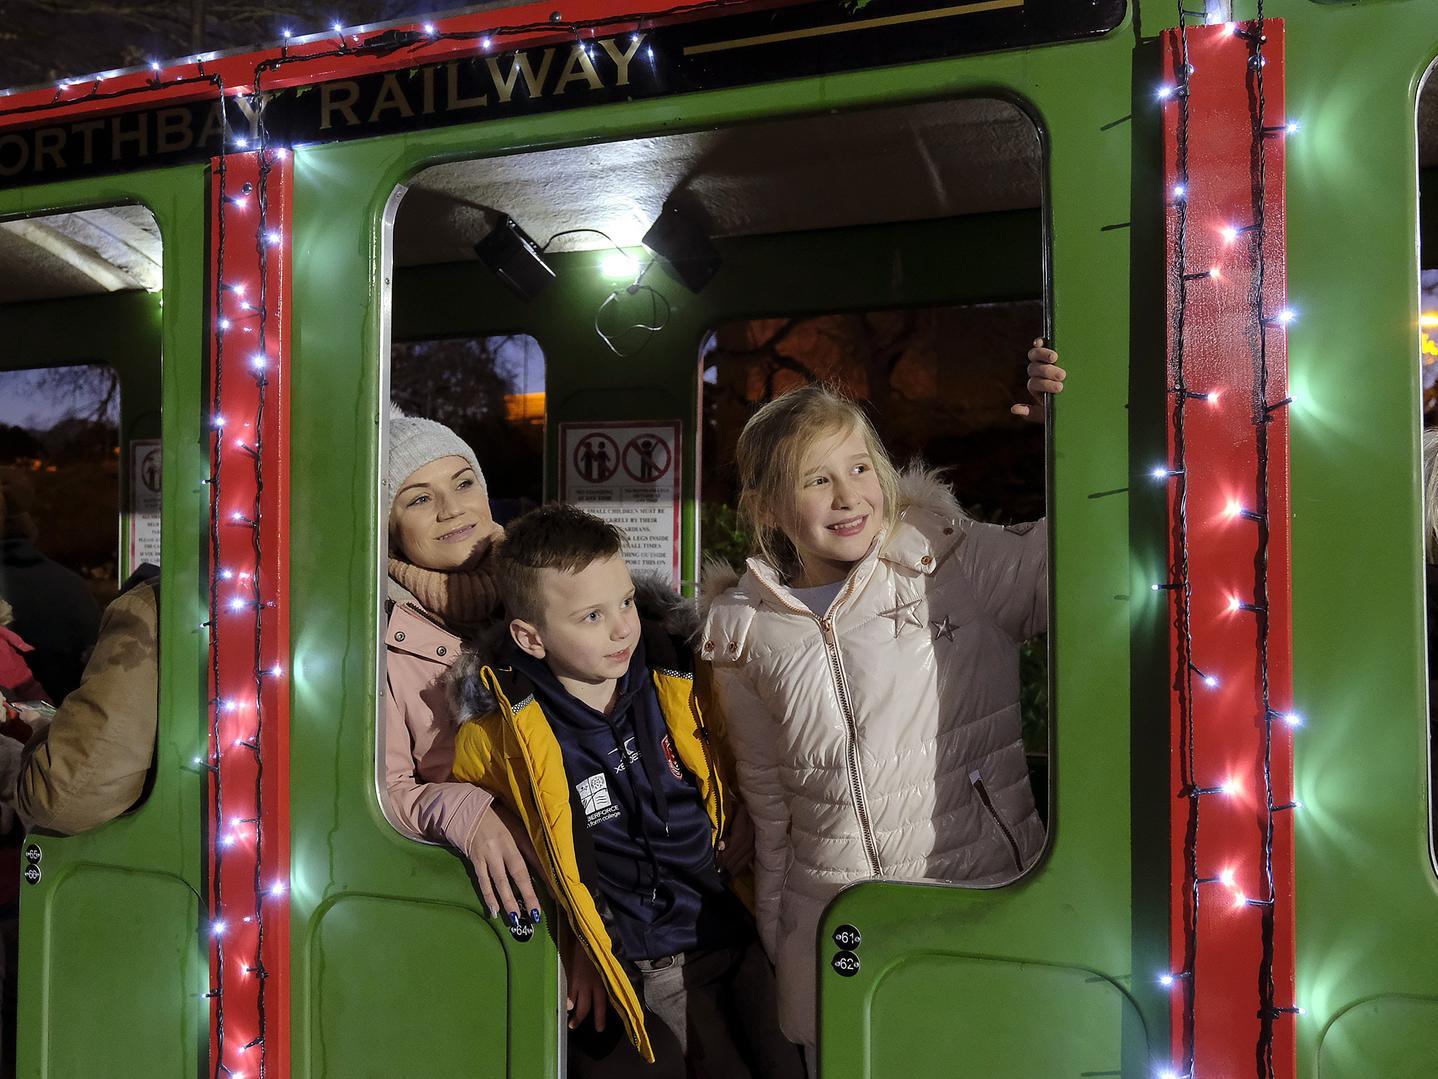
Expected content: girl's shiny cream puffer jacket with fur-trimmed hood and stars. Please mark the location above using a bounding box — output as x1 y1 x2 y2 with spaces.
699 472 1048 1044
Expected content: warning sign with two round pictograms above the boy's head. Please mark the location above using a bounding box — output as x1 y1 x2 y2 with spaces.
559 420 680 591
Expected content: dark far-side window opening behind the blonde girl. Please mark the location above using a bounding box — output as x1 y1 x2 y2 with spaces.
700 299 1048 820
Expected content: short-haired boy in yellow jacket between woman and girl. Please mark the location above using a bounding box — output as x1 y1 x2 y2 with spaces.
453 505 802 1079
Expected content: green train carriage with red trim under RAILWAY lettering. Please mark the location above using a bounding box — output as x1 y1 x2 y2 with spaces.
0 0 1438 1079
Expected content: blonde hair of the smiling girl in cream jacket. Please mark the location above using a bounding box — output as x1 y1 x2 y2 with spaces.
735 383 903 578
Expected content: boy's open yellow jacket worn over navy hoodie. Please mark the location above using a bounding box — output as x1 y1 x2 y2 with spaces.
450 588 752 1060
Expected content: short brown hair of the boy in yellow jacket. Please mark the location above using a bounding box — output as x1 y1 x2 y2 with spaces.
495 502 624 626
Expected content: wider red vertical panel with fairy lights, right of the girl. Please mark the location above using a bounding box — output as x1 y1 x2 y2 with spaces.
1159 19 1296 1079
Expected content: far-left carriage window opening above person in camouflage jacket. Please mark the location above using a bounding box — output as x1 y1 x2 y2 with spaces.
0 206 162 719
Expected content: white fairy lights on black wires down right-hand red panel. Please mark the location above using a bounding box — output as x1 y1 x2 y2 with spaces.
1153 0 1303 1079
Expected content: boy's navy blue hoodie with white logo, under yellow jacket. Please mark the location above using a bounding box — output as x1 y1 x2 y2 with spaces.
509 640 745 960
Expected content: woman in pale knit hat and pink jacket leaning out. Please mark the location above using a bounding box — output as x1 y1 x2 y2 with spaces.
381 409 539 927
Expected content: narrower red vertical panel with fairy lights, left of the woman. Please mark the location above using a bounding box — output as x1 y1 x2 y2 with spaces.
207 151 292 1079
